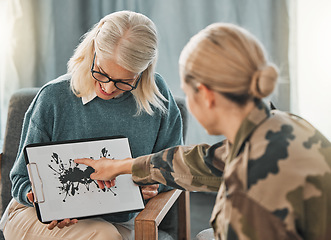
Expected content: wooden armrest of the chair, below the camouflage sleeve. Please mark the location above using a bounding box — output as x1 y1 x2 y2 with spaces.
135 189 189 240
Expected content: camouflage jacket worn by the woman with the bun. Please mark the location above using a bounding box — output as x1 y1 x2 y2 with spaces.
132 102 331 240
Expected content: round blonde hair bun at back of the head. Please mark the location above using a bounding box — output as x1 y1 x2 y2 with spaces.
250 65 278 98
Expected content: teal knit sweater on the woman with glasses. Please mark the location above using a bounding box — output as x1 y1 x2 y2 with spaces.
10 74 182 222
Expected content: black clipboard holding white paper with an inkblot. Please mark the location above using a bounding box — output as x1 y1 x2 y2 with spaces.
24 136 145 223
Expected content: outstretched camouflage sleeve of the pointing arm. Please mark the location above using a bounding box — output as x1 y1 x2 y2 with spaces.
132 143 225 191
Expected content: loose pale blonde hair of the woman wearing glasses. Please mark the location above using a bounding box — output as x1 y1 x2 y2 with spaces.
68 11 166 115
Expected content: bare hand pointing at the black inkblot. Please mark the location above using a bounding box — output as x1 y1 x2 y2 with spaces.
75 158 134 181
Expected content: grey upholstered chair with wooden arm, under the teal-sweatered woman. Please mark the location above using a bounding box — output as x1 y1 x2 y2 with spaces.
0 88 190 240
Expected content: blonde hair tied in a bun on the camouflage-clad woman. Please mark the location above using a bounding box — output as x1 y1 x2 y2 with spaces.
179 23 278 104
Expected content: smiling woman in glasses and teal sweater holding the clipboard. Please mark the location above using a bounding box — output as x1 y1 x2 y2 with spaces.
4 11 182 240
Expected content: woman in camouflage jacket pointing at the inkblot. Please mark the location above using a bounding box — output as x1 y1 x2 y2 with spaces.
76 23 331 240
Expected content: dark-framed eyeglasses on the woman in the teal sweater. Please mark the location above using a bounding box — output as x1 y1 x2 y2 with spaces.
91 53 141 92
